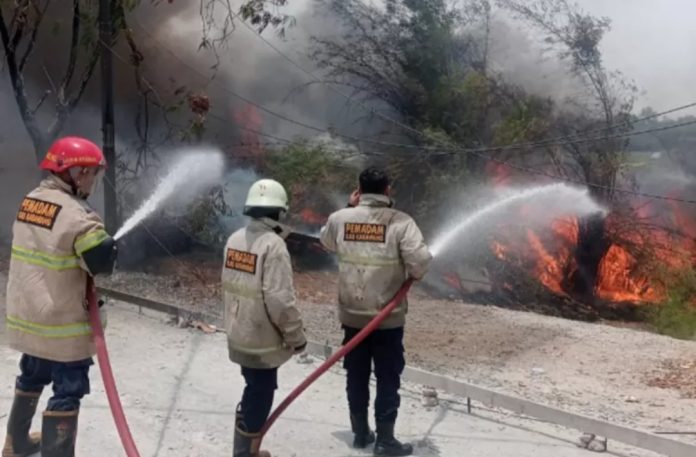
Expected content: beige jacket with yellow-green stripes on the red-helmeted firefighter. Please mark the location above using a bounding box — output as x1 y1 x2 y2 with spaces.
7 176 109 362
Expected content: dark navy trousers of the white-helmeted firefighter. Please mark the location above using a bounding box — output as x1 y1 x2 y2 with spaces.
240 367 278 433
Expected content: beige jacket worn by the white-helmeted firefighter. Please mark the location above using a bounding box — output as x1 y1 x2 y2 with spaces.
222 219 306 368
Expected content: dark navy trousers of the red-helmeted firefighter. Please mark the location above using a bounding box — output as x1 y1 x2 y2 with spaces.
15 354 94 411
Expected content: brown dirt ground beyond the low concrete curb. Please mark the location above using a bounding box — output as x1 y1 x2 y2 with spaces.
0 251 696 442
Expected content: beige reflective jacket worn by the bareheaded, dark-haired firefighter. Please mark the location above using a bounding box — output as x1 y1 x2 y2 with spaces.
321 194 432 328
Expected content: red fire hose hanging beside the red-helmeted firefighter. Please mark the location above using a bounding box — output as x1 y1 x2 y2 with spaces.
87 277 140 457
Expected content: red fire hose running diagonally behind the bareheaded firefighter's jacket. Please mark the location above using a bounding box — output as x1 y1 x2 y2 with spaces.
261 279 413 439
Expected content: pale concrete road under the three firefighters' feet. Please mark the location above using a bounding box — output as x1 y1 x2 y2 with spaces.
0 305 637 457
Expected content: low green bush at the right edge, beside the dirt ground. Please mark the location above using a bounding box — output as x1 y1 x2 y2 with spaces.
648 268 696 340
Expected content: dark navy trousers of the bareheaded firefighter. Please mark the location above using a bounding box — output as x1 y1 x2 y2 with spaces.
343 326 405 423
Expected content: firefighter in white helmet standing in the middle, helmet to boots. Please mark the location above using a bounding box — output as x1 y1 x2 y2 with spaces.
222 179 307 457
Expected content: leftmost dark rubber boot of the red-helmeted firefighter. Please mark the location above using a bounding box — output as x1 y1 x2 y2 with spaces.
2 390 41 457
